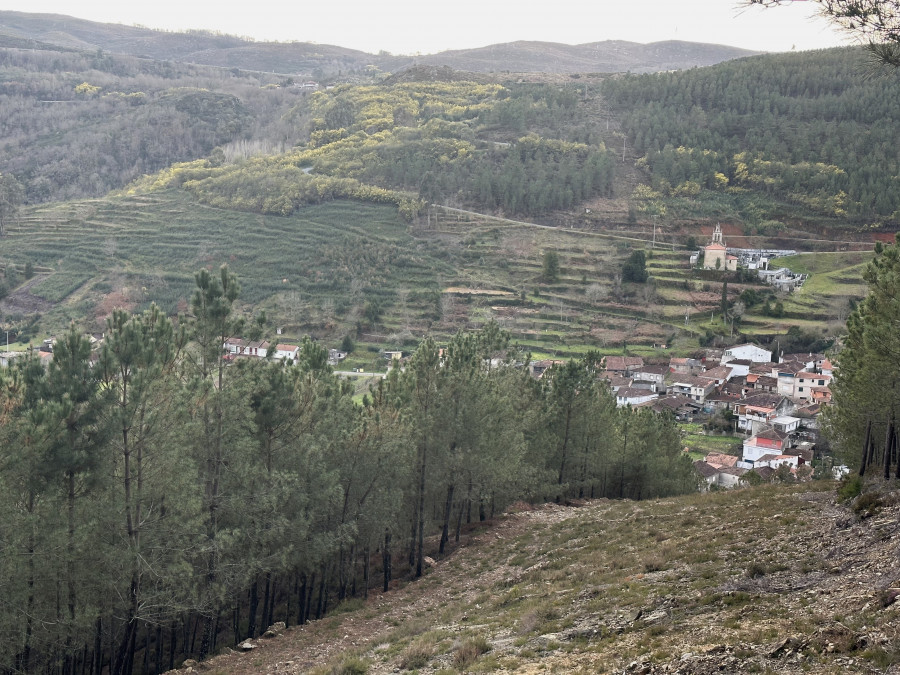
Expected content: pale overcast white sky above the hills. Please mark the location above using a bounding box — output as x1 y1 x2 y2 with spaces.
0 0 849 54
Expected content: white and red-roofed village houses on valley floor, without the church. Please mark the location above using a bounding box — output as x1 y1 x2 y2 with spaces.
218 338 833 489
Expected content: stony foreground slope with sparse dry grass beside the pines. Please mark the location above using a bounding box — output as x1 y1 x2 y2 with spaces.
165 483 900 675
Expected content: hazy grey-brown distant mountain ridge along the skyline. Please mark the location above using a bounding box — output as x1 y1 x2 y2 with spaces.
0 11 761 77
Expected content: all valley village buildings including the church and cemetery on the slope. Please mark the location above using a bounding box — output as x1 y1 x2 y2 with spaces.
0 225 842 490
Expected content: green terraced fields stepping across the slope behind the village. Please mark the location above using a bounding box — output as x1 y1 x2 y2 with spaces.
0 191 869 365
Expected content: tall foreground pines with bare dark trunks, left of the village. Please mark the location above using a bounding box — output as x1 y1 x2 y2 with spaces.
0 268 696 674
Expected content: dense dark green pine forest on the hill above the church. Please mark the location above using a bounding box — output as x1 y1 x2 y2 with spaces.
603 48 900 222
